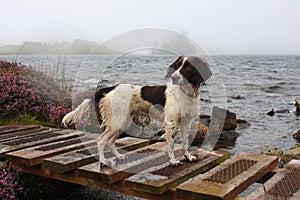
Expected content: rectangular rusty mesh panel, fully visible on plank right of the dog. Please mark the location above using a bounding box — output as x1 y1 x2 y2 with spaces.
206 159 257 184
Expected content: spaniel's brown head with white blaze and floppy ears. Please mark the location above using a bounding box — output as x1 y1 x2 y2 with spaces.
166 56 212 88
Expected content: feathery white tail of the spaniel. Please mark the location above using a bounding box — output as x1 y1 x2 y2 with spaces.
61 99 92 127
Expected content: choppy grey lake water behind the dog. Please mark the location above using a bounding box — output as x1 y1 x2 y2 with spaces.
0 55 300 154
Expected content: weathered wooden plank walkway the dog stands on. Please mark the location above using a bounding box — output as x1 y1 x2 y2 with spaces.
0 125 300 200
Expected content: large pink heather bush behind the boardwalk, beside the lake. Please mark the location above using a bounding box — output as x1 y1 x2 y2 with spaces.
0 61 72 127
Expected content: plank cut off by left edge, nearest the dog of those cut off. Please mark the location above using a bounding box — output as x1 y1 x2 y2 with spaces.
0 130 84 157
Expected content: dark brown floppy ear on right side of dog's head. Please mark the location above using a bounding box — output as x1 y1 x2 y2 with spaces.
191 58 212 88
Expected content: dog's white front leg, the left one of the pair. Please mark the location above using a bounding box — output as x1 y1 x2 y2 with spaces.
165 121 182 166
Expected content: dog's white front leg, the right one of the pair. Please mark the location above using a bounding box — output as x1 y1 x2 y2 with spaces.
180 119 197 162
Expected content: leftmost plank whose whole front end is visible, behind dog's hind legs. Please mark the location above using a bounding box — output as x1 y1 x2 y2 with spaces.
6 134 99 166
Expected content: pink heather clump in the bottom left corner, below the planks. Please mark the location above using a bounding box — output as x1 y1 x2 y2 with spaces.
0 161 23 200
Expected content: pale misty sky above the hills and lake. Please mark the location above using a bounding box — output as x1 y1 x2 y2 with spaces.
0 0 300 54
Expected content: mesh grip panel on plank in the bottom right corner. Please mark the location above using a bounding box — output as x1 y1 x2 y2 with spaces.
268 169 300 197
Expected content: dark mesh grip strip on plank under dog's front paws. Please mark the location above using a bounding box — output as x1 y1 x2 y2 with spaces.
152 155 210 177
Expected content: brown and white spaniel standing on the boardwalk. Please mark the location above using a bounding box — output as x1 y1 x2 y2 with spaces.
62 56 212 166
